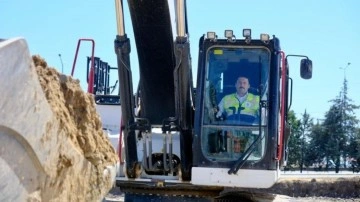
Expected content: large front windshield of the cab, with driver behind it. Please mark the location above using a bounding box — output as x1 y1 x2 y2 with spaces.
202 46 270 161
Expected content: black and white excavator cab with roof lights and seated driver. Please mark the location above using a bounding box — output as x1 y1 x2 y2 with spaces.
192 29 300 188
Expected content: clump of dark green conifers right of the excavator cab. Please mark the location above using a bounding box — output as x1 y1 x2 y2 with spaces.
287 78 360 172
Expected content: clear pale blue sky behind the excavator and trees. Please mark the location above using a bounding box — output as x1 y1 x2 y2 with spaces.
0 0 360 121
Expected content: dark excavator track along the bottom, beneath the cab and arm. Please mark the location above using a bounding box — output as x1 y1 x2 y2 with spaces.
119 182 277 202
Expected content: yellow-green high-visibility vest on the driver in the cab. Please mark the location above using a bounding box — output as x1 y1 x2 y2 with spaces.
223 93 260 116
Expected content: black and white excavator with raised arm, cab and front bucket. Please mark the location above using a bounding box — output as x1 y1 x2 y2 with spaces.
0 0 312 201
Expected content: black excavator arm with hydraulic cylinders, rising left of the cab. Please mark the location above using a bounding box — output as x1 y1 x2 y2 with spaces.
115 0 193 180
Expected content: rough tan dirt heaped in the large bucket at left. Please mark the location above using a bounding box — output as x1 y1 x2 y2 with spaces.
30 56 118 201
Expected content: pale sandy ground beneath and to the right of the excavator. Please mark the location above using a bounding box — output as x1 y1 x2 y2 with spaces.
105 174 360 202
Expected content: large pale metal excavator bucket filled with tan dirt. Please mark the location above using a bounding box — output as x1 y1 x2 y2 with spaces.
0 38 116 201
